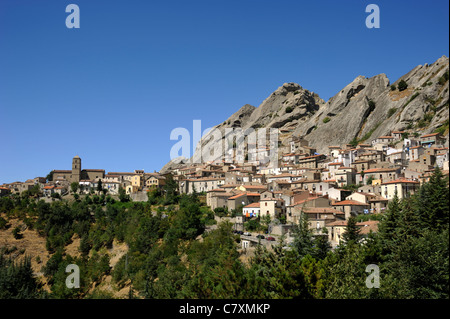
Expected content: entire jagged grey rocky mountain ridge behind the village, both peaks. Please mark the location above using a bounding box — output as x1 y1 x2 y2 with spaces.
163 56 449 170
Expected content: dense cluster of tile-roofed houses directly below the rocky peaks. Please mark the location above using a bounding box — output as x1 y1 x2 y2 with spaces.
167 131 449 246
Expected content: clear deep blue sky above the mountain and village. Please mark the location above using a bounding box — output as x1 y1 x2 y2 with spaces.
0 0 449 183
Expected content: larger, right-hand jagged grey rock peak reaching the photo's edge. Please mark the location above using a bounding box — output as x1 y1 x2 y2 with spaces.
293 56 449 152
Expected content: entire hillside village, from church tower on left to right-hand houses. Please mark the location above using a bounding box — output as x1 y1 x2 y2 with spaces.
0 131 449 247
